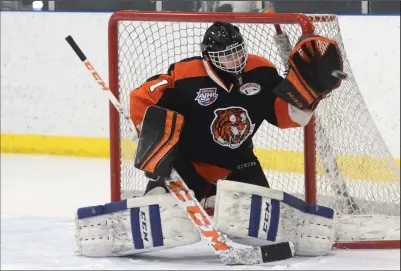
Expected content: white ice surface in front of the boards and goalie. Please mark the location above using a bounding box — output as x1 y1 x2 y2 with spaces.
1 154 400 270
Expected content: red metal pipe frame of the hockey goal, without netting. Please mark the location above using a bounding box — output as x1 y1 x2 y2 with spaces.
108 10 400 249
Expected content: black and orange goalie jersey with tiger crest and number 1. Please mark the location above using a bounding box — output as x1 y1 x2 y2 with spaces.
130 55 308 187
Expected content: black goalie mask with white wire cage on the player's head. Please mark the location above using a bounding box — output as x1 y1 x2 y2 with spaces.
201 22 248 74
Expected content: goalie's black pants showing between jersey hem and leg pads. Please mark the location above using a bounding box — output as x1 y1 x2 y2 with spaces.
145 157 270 200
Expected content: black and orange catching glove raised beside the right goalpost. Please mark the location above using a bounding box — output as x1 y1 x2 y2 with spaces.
273 35 343 111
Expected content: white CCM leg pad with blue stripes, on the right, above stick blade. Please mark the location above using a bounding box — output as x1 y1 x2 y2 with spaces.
214 180 335 256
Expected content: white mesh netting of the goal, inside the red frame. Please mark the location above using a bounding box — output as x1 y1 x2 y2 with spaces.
111 12 400 224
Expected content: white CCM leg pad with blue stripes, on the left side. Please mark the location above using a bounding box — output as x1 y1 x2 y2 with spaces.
75 193 200 257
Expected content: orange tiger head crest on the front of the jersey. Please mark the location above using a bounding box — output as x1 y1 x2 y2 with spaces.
210 107 255 149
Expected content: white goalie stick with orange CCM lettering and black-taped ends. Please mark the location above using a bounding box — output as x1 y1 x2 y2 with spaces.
65 36 294 265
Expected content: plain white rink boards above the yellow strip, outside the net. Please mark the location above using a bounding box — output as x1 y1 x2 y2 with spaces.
0 12 400 158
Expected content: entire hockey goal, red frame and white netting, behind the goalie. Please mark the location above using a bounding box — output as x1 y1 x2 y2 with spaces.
108 11 400 252
